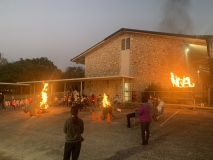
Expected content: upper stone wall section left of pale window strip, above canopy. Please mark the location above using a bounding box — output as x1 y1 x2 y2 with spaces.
85 37 121 77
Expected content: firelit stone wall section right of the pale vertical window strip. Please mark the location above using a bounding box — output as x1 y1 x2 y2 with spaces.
130 34 190 91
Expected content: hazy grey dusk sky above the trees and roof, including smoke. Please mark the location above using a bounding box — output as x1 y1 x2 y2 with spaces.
0 0 213 71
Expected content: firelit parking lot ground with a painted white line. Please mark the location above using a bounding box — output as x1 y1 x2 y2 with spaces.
0 105 213 160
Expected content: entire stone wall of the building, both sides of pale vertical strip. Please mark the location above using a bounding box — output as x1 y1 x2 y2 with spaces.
84 33 191 99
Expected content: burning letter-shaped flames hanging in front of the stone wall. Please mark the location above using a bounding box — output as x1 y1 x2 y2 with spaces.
171 73 195 88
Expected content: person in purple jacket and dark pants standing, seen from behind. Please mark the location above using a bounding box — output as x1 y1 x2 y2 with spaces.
138 97 152 145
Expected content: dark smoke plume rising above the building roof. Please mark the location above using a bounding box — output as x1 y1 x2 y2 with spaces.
159 0 193 34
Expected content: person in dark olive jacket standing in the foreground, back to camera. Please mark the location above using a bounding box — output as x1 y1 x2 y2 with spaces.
63 106 84 160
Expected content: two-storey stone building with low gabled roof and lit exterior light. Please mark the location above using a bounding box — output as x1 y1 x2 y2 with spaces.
71 28 213 101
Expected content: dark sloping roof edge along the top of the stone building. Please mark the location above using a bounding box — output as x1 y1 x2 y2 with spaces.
70 28 212 64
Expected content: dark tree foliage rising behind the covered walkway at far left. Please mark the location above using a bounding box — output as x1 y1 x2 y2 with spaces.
0 57 62 83
